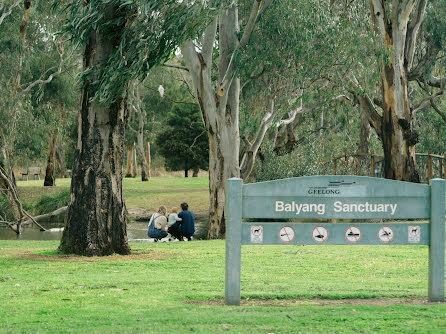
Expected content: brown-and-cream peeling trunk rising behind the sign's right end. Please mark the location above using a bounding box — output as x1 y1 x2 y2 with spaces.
370 0 426 182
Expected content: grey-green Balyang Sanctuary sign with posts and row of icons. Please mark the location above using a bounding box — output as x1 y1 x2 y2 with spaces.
225 175 445 305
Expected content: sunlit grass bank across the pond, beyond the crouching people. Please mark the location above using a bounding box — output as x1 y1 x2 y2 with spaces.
17 176 209 213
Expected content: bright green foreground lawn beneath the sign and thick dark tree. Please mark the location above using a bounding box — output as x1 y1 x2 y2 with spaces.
0 240 446 334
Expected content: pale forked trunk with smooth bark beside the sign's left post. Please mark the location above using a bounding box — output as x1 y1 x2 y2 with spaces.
181 0 270 239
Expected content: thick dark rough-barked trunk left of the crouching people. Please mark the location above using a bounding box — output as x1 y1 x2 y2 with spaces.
60 5 130 256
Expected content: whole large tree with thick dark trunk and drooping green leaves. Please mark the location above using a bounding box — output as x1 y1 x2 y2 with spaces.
60 0 218 256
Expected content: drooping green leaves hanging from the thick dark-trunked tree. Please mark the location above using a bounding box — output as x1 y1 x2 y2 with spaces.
60 0 223 103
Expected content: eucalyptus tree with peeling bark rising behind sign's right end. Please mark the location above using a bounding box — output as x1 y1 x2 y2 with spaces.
353 0 445 182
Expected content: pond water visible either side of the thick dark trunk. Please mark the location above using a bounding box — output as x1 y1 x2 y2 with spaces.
0 222 148 241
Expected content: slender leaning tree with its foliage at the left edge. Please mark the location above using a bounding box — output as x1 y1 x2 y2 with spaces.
0 0 71 227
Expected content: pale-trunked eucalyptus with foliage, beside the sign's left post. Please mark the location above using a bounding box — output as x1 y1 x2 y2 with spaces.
181 0 372 238
